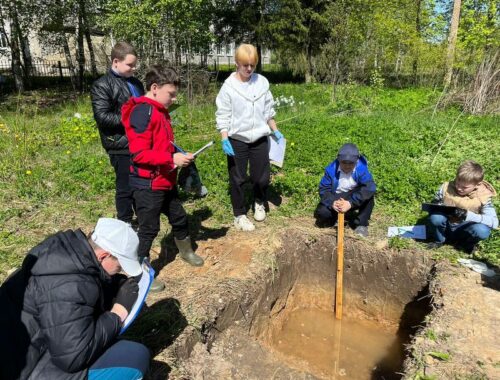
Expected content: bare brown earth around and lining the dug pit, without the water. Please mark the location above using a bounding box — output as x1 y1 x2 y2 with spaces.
127 219 500 379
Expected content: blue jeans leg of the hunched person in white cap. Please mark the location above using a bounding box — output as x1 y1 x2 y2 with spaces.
88 340 150 380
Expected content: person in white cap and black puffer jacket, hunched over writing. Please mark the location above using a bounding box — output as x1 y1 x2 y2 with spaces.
0 218 150 380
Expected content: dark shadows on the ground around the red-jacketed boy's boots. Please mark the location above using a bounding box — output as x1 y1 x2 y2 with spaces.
151 207 229 273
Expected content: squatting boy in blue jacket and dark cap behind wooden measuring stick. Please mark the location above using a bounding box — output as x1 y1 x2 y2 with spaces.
314 143 376 237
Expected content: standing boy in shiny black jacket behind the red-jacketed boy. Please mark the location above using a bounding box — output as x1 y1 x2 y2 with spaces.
90 42 144 223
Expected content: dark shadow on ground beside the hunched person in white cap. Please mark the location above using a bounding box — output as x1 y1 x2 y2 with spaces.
123 298 188 379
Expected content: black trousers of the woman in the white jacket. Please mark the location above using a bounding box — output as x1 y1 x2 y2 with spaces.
227 136 271 216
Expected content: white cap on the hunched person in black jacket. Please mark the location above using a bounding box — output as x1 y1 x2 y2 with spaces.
92 218 142 276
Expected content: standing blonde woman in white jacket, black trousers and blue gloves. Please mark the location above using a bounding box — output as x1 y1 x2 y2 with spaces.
215 44 283 231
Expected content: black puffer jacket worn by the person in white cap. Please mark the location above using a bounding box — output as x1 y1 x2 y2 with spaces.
0 230 121 380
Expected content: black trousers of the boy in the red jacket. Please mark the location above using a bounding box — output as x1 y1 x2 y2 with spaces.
134 188 189 259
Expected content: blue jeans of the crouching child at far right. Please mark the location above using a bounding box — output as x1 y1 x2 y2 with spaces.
429 214 491 252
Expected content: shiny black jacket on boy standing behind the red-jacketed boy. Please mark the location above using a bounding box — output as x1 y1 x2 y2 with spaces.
90 70 144 154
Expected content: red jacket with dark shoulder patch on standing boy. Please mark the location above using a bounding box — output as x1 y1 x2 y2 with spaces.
122 96 177 190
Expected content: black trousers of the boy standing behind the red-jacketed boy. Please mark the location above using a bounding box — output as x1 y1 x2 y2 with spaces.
109 154 135 223
